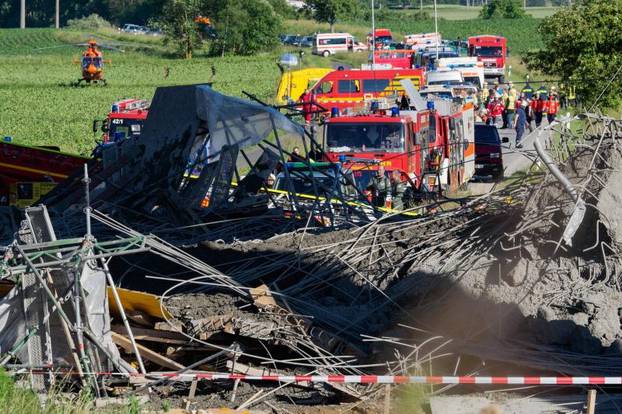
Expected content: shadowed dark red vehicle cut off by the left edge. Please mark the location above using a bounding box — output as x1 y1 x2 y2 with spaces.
0 140 88 207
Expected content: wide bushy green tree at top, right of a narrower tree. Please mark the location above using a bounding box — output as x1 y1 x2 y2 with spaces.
206 0 282 55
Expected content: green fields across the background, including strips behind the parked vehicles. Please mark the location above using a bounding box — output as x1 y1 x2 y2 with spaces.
0 14 539 154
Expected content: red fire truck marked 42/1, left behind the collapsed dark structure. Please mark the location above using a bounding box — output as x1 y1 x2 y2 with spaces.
93 99 149 144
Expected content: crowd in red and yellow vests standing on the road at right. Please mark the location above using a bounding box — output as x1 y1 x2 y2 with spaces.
476 82 560 148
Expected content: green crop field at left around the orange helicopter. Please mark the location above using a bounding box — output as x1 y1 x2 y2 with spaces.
0 29 279 154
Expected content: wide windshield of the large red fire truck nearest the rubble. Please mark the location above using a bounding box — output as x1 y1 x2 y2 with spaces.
326 122 404 152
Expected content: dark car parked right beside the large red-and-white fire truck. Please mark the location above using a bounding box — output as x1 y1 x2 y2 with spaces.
474 123 508 180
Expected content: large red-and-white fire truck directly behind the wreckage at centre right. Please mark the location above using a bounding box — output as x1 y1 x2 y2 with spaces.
324 102 475 192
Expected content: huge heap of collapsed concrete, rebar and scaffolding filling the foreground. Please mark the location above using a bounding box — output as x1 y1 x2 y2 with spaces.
0 87 622 412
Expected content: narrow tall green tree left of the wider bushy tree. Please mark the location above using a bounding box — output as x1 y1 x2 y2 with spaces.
159 0 201 59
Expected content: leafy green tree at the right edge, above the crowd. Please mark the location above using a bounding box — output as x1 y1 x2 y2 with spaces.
523 0 622 108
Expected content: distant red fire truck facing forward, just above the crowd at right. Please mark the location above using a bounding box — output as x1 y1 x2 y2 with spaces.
468 35 508 82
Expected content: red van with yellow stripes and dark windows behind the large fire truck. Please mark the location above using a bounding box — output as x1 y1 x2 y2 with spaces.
312 69 425 111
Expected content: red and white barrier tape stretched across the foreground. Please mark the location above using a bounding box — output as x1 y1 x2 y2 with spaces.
12 370 622 385
